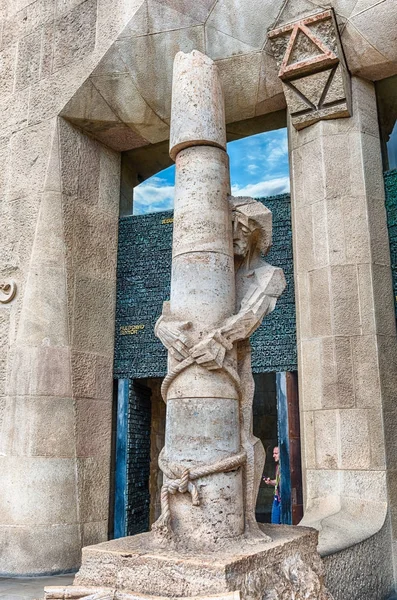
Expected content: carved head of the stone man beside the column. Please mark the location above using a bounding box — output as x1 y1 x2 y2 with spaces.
230 196 272 258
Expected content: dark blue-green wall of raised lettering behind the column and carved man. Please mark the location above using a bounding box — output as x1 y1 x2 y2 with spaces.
114 194 297 379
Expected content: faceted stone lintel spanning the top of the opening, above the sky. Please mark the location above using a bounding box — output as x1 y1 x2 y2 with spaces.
55 0 397 150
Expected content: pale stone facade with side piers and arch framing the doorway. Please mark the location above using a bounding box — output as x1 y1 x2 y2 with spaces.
0 0 397 598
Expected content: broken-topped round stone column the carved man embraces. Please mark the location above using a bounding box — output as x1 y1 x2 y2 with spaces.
158 51 244 545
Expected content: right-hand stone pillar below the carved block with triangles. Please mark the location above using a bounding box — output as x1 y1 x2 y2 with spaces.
289 78 396 554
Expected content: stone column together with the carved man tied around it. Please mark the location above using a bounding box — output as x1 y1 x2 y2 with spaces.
154 51 285 550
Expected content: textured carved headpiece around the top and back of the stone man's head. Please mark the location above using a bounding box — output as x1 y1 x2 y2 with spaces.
229 196 272 254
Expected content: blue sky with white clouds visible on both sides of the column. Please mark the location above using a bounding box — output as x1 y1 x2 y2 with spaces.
134 129 289 215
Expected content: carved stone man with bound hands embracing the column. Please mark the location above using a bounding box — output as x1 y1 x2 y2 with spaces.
155 196 286 539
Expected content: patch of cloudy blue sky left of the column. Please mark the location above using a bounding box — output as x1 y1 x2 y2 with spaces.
133 177 175 215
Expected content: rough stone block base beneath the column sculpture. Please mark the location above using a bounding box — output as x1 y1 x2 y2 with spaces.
46 525 331 600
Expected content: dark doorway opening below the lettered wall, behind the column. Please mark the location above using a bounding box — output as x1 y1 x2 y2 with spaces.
114 372 303 537
